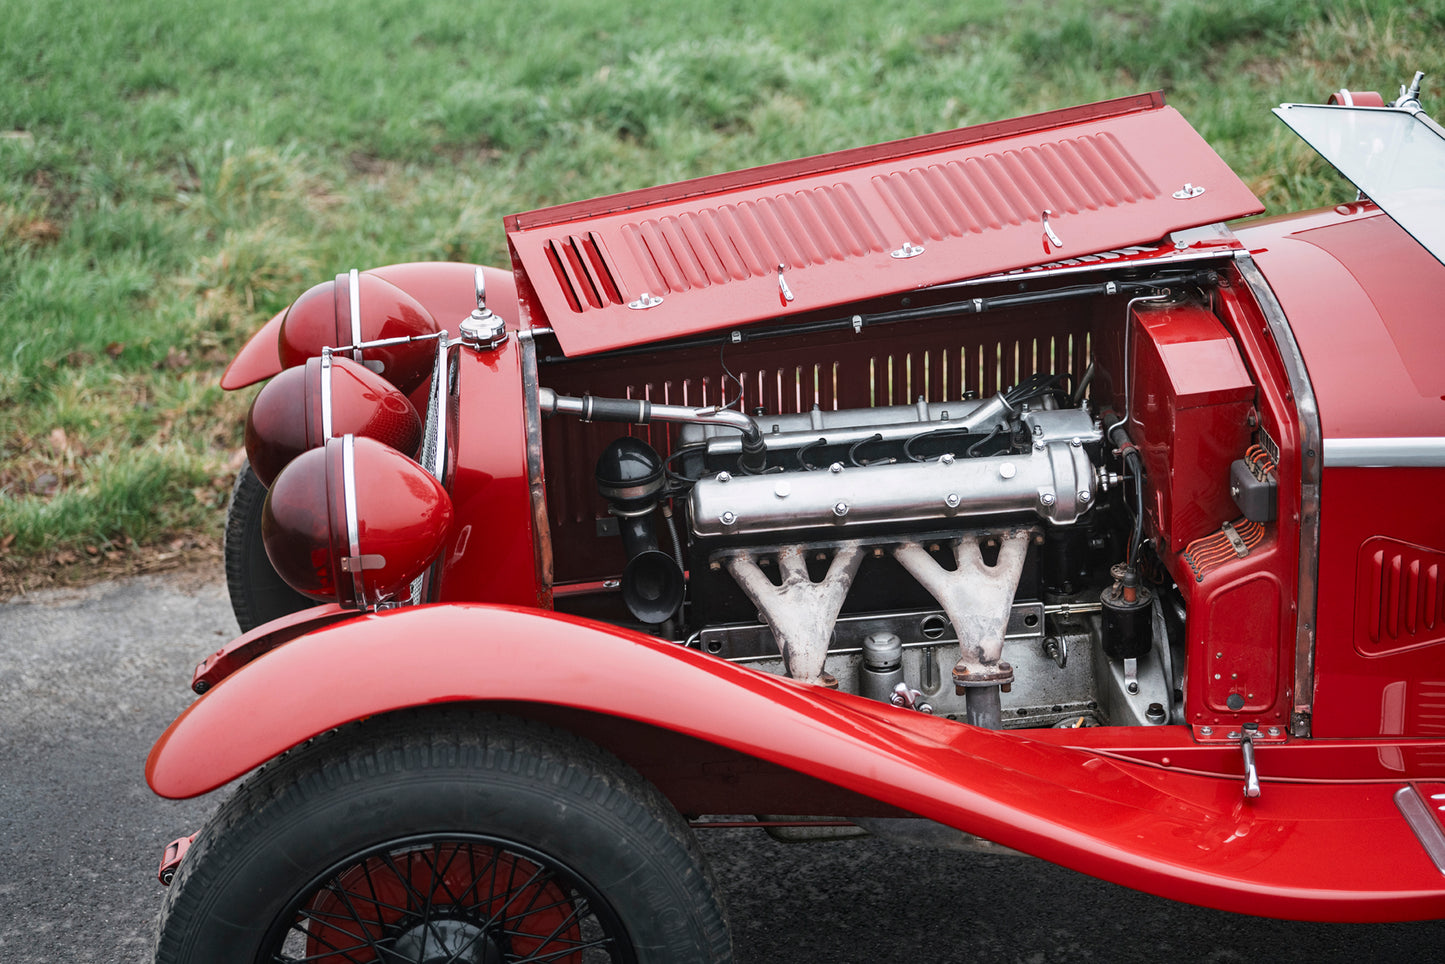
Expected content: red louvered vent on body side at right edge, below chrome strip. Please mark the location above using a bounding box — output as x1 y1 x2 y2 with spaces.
1355 536 1445 655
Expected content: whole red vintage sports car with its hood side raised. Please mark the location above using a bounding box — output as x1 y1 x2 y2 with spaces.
146 77 1445 964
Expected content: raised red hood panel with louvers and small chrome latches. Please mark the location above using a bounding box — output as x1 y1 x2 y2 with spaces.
506 94 1263 356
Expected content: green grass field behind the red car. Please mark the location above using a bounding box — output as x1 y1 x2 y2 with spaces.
0 0 1445 588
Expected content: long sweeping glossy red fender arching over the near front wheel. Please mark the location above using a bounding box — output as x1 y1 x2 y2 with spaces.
146 604 1445 921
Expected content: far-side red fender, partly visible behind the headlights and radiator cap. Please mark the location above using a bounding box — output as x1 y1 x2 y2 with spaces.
221 262 517 392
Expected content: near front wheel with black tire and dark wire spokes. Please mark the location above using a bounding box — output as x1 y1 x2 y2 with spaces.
156 710 733 964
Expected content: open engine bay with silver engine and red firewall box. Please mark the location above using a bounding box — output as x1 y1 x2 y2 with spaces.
514 260 1287 727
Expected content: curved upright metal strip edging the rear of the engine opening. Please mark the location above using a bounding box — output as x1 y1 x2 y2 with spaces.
1234 254 1324 737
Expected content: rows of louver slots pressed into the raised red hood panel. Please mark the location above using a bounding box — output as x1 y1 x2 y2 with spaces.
580 134 1159 312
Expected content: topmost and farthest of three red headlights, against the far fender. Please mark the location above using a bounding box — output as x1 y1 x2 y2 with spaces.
276 272 441 395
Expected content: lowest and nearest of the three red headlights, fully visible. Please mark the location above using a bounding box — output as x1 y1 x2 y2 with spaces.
262 435 452 607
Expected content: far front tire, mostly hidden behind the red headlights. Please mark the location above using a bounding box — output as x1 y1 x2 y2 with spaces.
221 462 316 633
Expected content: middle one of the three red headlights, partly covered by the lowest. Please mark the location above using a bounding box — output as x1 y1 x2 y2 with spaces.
246 356 422 487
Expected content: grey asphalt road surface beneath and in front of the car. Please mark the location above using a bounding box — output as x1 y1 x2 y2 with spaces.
0 574 1445 964
